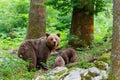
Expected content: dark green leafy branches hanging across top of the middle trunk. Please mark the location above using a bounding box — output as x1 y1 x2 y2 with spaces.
46 0 105 15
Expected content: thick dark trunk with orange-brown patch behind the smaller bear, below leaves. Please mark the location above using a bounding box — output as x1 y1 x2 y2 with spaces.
69 5 94 48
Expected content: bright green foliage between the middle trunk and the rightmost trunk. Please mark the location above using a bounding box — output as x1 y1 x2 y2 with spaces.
94 3 113 43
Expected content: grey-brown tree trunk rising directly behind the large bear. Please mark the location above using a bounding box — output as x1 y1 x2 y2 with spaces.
26 0 46 39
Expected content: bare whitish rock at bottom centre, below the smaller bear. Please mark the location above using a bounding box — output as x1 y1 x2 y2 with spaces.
64 69 81 80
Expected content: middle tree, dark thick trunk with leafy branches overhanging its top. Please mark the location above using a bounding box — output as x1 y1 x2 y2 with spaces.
47 0 105 48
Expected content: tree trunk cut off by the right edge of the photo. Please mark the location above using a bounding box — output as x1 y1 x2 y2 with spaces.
109 0 120 80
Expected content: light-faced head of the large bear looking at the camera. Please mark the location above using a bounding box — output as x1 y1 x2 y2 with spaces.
46 33 60 50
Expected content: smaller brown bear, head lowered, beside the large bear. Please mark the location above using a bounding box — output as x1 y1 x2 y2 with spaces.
55 48 77 66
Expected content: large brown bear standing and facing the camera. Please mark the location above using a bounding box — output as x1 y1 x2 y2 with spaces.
18 33 60 71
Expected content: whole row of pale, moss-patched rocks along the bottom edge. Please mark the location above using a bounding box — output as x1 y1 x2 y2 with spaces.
35 67 108 80
